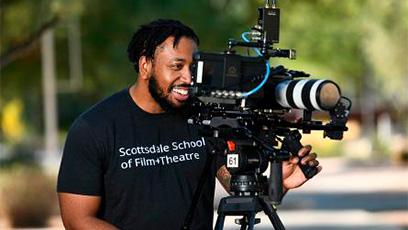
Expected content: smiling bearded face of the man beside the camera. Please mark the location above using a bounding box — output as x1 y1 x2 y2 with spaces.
149 37 197 110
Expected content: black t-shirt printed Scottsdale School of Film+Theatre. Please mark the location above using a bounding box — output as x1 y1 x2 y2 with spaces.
57 89 217 229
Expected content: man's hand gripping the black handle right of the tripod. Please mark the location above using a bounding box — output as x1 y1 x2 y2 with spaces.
282 145 322 192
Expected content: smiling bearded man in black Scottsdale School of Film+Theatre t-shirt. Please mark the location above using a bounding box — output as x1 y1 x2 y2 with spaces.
58 20 321 229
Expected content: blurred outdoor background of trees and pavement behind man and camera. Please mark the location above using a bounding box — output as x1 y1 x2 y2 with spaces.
0 0 408 229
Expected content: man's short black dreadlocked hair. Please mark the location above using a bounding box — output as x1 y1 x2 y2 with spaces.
127 19 199 72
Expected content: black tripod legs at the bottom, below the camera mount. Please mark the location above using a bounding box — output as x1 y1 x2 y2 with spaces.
214 196 285 230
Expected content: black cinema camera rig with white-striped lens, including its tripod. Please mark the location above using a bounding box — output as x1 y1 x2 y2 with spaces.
184 1 351 229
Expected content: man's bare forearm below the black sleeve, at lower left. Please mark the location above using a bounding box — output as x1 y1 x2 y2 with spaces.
58 193 118 230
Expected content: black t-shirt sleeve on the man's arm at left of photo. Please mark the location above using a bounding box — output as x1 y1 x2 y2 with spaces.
57 118 103 196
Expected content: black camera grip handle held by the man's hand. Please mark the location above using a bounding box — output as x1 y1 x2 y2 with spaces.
282 130 317 179
